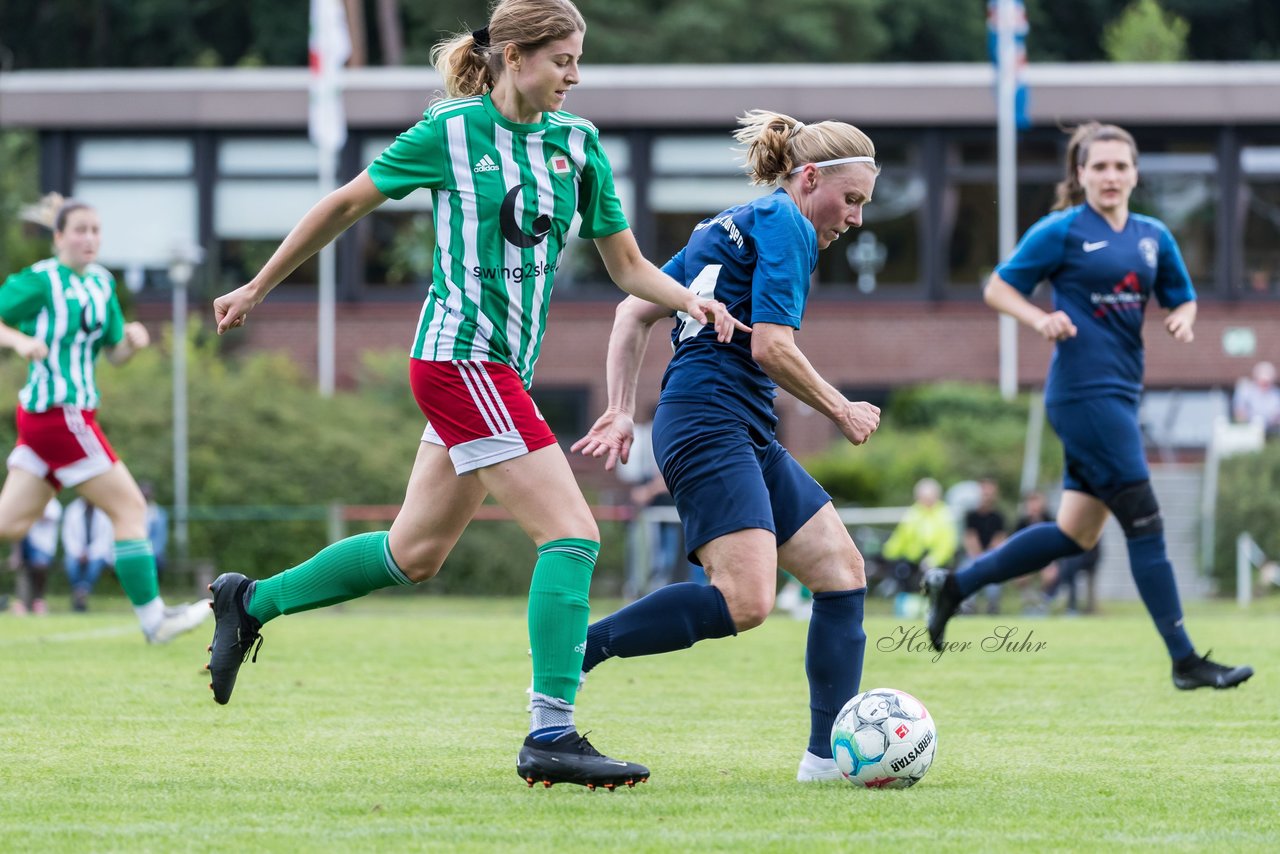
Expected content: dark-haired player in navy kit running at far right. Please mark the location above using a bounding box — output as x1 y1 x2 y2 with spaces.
924 123 1253 689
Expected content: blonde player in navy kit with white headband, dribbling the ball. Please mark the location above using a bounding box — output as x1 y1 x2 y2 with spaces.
573 111 879 782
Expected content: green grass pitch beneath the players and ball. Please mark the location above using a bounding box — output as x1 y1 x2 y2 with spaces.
0 595 1280 851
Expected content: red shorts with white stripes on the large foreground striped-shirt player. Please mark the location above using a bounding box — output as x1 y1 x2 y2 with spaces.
408 359 556 475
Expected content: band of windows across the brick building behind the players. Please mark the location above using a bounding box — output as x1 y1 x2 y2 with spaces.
64 127 1280 301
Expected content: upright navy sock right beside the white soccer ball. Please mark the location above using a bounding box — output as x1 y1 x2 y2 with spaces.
804 588 867 759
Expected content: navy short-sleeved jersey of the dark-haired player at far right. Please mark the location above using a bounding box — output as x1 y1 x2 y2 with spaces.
996 205 1196 403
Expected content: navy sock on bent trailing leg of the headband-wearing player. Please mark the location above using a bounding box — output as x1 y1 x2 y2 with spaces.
582 581 737 672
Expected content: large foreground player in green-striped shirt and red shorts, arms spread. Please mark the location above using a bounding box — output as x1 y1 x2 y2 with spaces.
209 0 735 789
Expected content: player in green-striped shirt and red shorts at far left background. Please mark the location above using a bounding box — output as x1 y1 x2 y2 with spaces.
0 200 209 644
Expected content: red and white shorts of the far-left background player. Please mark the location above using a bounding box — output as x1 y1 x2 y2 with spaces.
9 406 119 489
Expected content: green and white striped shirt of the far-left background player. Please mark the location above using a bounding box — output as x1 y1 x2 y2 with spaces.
0 259 124 412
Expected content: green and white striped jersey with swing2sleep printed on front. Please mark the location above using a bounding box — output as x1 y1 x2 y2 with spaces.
369 95 627 388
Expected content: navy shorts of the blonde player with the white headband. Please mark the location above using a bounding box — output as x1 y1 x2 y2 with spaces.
653 401 831 565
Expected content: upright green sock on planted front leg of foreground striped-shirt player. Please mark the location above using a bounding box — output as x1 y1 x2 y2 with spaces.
529 539 600 703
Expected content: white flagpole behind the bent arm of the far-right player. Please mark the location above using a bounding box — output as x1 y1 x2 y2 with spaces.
996 0 1018 399
